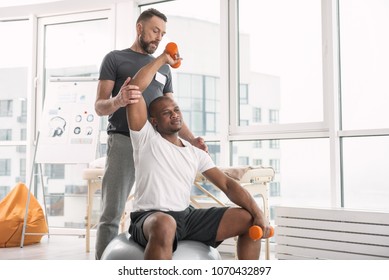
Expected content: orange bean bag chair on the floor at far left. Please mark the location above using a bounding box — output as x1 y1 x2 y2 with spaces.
0 183 48 248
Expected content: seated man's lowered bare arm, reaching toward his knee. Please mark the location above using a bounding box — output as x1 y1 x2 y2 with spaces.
203 167 267 228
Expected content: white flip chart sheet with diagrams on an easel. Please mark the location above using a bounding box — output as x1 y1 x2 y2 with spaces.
35 79 99 163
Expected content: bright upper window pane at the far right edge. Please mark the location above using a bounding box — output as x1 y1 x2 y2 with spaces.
339 0 389 130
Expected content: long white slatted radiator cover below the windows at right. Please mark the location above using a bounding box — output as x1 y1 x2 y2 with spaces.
275 207 389 260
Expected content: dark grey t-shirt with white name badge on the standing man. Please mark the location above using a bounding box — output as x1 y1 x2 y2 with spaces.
99 49 173 135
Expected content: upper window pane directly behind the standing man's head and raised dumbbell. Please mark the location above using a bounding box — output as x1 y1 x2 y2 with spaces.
141 0 222 136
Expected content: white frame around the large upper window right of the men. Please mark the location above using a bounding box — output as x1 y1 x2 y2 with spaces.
228 0 342 207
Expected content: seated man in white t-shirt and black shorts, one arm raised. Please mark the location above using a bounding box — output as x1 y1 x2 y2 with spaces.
121 47 270 259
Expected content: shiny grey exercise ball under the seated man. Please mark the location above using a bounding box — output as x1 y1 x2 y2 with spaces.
101 232 221 260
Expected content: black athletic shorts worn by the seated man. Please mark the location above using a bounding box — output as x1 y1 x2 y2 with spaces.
129 206 228 252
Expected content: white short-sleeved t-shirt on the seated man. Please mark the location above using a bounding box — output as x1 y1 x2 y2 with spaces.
130 121 215 211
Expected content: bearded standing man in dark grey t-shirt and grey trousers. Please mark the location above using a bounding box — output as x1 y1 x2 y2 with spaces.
95 9 207 259
